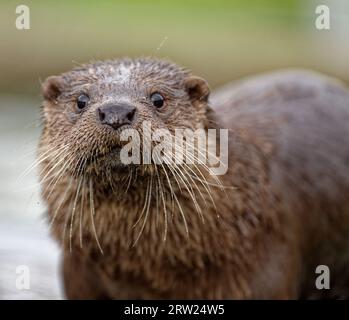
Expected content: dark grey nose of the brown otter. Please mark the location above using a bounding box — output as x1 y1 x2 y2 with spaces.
97 104 136 129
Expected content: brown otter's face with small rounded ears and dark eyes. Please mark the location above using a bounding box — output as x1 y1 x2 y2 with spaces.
40 59 209 181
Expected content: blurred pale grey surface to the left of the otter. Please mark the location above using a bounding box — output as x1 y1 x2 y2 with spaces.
0 95 62 299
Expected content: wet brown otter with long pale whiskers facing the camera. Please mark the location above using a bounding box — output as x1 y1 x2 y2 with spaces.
38 58 349 299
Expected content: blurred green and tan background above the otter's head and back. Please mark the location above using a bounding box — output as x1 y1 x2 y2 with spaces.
0 0 349 93
